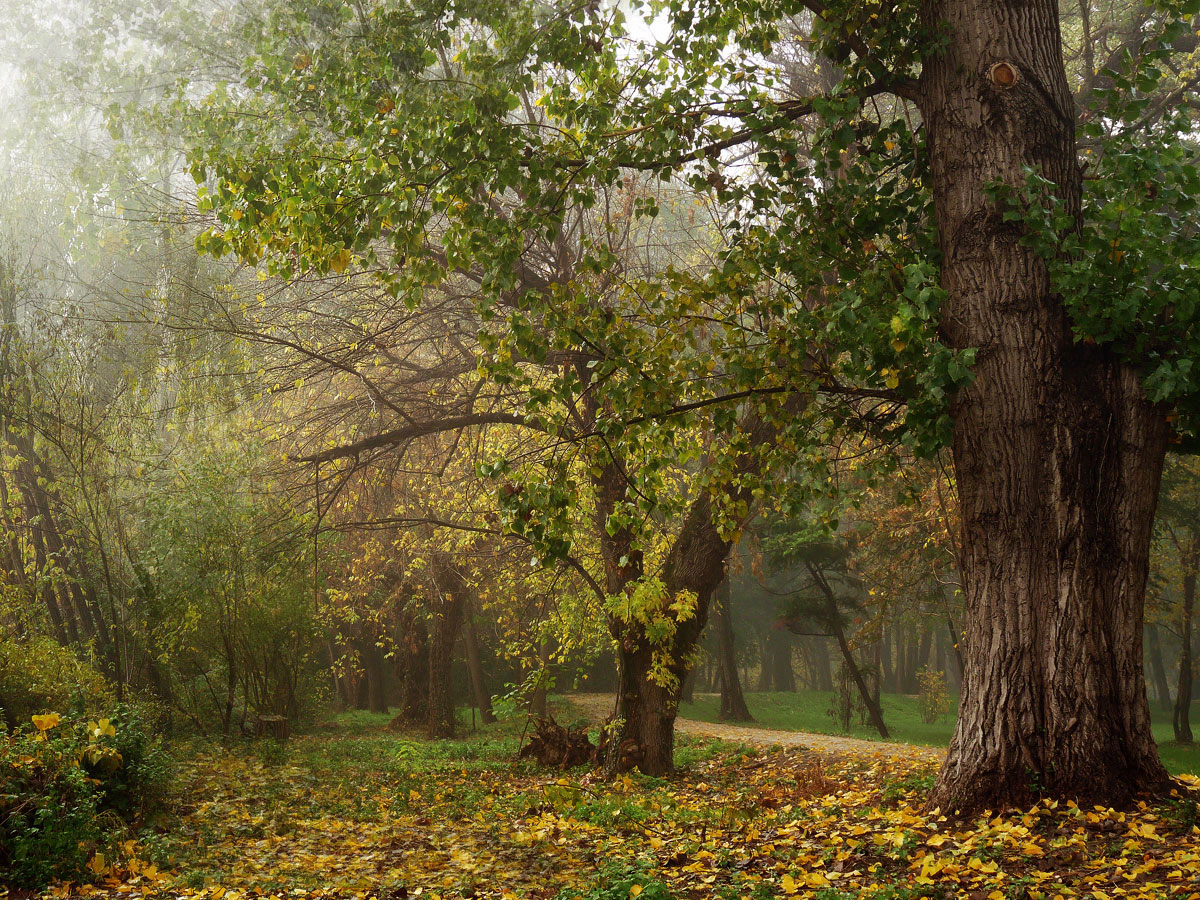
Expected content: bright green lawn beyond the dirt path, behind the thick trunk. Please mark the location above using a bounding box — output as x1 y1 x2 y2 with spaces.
679 691 1200 775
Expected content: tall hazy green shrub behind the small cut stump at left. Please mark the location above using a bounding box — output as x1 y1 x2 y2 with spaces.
142 442 316 732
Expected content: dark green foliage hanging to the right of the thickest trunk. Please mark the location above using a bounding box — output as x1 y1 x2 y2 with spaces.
994 15 1200 427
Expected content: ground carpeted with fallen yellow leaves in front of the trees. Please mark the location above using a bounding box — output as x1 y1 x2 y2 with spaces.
25 714 1200 900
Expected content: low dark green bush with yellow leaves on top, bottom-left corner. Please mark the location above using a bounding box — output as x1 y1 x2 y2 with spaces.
0 706 169 889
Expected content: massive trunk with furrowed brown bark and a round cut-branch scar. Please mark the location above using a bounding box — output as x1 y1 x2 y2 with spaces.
920 0 1168 812
